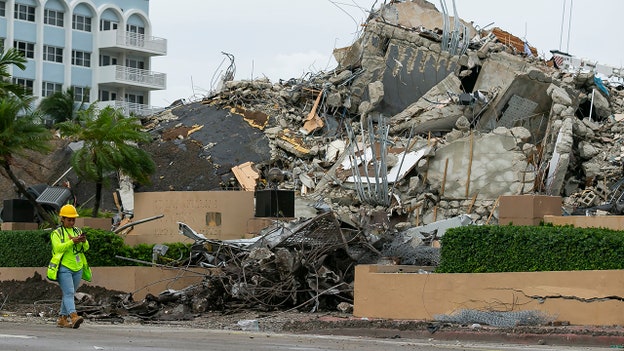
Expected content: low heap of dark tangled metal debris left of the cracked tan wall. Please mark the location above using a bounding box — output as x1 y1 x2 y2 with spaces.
94 212 379 319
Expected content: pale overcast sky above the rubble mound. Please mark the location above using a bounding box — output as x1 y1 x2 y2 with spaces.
150 0 624 106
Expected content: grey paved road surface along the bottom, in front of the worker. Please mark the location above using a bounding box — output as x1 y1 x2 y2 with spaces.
0 322 606 351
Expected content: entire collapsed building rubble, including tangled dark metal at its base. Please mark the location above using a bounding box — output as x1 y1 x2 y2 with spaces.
13 0 624 317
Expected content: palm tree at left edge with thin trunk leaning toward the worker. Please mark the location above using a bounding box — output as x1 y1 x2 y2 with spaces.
0 94 55 224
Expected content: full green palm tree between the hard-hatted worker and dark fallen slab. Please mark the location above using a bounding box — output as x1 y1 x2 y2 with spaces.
57 104 156 217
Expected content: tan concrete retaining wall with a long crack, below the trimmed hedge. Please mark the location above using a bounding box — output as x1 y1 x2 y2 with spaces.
353 265 624 326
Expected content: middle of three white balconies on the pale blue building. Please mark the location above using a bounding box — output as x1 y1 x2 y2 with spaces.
98 65 167 90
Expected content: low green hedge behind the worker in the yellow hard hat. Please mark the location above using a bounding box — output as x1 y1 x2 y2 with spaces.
0 227 190 267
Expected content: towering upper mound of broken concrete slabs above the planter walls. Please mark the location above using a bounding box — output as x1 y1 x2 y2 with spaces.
143 1 624 230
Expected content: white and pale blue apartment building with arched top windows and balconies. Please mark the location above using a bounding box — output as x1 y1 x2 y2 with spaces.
0 0 167 115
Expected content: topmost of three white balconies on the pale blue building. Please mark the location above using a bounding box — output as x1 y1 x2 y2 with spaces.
100 30 167 55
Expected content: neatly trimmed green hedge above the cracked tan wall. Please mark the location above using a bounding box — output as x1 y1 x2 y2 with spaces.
436 225 624 273
